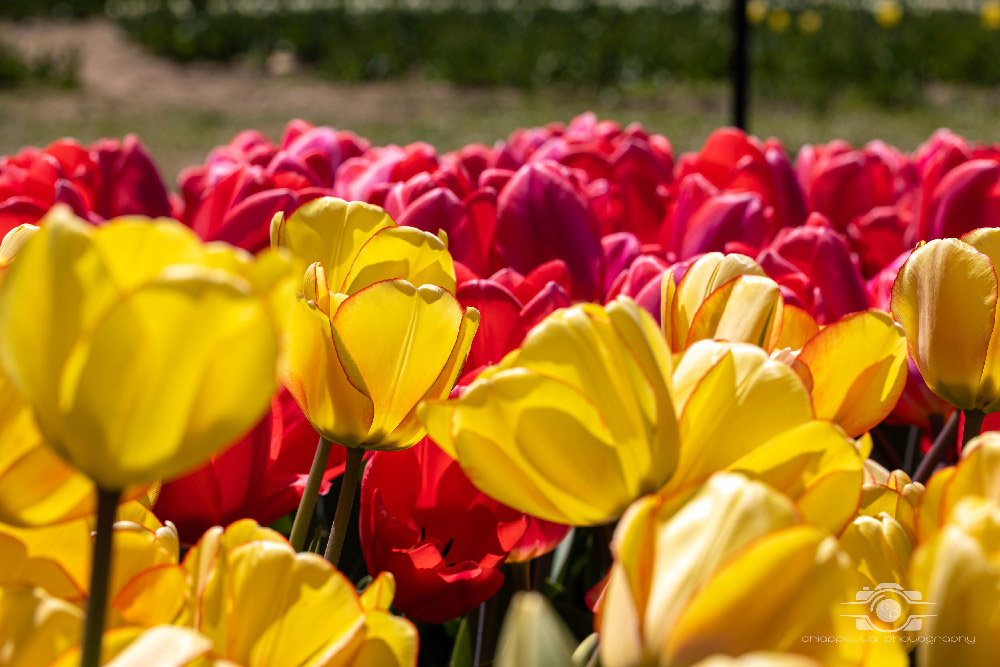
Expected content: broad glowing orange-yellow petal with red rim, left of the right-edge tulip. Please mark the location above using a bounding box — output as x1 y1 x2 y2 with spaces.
798 310 907 437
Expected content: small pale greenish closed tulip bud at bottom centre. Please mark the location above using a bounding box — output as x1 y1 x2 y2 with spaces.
494 592 576 667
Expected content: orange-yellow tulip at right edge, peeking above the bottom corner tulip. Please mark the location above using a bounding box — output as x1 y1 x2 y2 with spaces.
917 431 1000 542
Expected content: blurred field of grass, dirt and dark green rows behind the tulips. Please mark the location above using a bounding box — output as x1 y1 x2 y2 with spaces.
0 0 1000 179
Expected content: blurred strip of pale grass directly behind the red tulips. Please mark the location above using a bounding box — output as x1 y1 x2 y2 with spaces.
0 81 1000 182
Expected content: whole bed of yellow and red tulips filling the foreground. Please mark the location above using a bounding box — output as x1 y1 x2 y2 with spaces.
0 114 1000 667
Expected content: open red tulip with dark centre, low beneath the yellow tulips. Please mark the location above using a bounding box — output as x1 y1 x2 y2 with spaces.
360 438 528 623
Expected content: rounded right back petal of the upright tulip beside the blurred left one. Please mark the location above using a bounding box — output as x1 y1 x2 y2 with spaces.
342 227 455 294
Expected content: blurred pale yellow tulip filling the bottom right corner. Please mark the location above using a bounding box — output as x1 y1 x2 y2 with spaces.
909 496 1000 667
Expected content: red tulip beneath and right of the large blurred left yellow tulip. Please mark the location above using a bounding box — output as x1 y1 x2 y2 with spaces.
153 389 345 544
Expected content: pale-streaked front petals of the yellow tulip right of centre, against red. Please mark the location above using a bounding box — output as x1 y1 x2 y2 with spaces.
686 275 784 352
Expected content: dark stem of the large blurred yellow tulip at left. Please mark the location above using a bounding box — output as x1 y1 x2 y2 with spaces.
80 488 121 667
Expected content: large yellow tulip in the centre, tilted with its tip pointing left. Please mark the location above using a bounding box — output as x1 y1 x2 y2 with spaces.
418 299 679 525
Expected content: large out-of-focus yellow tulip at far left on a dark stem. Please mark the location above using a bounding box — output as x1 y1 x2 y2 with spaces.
0 207 290 490
